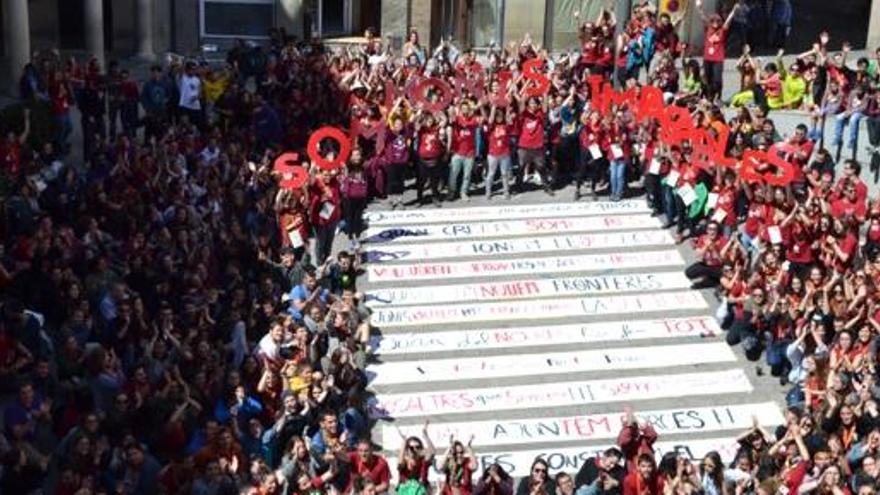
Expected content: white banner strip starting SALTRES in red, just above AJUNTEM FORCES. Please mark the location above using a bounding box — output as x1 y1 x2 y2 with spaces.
368 369 752 419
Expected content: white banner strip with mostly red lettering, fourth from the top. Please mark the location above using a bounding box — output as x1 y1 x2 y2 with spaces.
366 249 684 283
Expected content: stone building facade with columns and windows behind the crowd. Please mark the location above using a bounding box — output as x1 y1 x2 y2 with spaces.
0 0 880 92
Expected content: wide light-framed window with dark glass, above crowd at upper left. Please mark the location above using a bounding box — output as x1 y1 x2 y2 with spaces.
200 0 275 38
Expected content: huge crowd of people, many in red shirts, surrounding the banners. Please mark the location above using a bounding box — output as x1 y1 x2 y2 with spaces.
0 1 880 495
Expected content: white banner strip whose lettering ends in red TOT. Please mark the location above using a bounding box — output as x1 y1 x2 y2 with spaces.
371 316 721 356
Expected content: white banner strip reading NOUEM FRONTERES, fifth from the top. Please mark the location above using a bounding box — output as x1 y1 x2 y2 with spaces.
366 271 691 307
